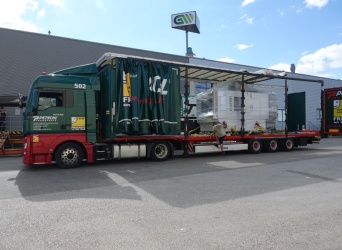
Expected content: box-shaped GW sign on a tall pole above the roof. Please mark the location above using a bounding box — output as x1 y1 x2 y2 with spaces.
171 11 200 33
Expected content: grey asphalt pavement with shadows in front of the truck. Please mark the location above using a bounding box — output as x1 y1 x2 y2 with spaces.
0 137 342 250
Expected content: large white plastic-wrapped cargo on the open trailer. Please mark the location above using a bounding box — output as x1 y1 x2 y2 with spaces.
197 82 277 131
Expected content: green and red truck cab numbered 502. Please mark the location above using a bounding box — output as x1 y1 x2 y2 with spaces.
23 64 100 165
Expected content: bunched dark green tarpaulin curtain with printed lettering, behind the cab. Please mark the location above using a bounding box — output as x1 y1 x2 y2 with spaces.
112 58 180 135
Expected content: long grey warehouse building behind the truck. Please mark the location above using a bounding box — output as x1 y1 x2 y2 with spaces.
0 28 342 130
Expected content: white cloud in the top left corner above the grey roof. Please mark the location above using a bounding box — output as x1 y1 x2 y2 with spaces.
0 0 38 32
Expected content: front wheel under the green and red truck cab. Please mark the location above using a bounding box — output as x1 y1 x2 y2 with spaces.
55 143 83 168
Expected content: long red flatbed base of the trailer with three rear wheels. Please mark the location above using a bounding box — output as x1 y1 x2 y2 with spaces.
115 130 320 154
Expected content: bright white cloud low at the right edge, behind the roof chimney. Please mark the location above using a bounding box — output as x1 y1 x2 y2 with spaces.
270 44 342 78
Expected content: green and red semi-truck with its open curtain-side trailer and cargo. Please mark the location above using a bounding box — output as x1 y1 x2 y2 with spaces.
23 53 323 168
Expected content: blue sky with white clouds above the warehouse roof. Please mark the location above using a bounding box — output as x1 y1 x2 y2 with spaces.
0 0 342 79
